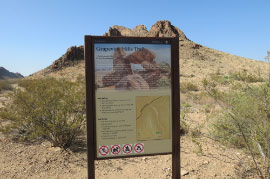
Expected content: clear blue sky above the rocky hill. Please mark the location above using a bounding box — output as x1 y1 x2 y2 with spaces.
0 0 270 75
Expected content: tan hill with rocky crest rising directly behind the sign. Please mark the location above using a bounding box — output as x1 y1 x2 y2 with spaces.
33 20 268 84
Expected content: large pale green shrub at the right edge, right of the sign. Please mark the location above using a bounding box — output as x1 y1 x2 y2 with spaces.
212 84 270 150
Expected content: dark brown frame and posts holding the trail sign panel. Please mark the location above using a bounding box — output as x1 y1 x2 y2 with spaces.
84 35 181 179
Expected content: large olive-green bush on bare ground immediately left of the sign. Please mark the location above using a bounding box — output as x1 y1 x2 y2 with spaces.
0 78 85 148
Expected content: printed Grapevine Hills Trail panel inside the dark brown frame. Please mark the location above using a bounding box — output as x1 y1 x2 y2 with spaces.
93 39 172 158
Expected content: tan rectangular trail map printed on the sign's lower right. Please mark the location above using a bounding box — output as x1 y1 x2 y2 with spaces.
136 96 170 140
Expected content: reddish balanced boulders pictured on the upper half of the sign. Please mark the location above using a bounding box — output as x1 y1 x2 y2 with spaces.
102 48 161 89
